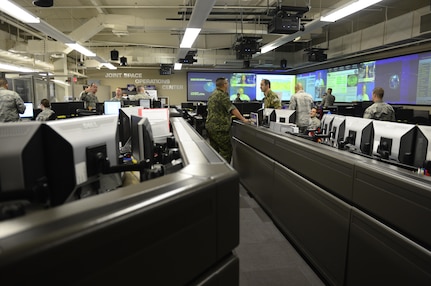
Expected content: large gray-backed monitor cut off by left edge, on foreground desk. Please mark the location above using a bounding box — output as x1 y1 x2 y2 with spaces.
0 122 46 202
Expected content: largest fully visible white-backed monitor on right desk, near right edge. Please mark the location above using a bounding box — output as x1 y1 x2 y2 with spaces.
373 120 416 165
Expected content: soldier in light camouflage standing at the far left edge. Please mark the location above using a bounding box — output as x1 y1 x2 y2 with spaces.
0 78 25 122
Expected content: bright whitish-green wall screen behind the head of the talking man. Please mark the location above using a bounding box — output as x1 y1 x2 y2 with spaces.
255 74 296 101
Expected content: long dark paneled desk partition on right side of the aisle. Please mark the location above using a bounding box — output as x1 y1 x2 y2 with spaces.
233 121 431 286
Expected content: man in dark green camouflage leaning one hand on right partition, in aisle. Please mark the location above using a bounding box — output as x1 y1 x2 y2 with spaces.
205 78 249 163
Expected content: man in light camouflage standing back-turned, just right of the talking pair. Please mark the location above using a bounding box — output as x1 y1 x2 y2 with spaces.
289 83 314 133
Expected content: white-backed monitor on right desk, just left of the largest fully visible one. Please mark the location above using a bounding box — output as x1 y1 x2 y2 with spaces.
344 116 374 155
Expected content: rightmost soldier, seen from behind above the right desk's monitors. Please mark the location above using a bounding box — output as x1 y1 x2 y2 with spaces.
364 87 395 121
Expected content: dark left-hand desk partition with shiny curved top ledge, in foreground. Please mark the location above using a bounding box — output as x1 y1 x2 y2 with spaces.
0 118 239 286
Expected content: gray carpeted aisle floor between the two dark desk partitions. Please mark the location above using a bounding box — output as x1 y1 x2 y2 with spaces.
235 186 325 286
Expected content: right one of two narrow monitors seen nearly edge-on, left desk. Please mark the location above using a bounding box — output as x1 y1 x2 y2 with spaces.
130 115 154 166
